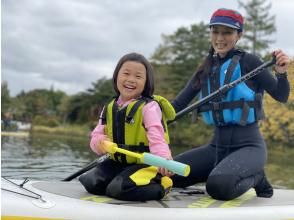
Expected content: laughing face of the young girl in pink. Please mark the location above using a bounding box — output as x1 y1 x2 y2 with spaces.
117 61 147 101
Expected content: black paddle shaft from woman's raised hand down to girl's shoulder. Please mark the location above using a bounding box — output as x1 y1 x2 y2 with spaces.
168 56 276 124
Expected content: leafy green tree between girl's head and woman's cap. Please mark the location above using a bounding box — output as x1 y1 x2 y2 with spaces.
151 22 210 97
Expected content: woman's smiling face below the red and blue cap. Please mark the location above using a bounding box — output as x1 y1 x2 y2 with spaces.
210 25 242 57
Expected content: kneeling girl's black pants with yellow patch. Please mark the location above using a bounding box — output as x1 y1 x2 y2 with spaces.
79 159 171 201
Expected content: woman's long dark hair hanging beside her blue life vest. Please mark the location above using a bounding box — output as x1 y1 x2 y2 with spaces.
192 47 214 89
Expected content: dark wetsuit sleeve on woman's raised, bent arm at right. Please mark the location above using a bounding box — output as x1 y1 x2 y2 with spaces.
241 54 290 102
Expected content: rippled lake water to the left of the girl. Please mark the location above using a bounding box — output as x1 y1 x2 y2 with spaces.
1 135 95 180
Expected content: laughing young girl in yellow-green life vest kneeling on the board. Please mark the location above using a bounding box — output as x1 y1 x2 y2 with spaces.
79 53 175 201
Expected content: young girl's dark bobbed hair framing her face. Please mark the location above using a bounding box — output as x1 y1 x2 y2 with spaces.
112 53 154 97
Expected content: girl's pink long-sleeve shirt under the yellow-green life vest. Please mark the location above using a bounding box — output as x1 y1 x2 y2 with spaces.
90 98 171 159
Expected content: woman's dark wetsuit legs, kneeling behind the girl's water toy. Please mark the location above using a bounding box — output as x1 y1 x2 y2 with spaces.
172 124 267 200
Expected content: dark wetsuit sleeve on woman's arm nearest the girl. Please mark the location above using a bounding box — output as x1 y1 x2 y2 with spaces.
172 77 200 112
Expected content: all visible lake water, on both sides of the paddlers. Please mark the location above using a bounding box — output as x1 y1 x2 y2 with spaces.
1 134 294 189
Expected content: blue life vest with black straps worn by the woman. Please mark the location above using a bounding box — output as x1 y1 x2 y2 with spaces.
199 55 263 126
